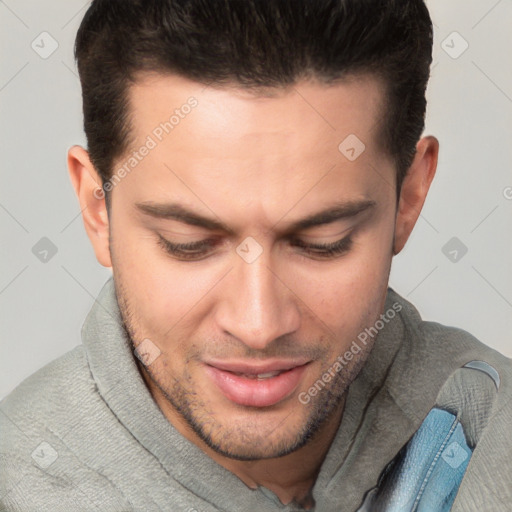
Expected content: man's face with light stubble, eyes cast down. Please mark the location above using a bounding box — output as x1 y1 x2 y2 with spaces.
109 76 396 459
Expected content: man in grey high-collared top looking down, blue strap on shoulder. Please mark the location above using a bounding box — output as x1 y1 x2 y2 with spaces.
1 0 512 512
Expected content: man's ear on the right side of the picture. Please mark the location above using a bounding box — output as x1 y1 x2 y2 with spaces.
393 136 439 254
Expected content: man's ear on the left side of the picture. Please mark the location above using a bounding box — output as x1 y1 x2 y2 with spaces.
68 146 112 267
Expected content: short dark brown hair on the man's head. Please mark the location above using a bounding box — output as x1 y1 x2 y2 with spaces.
75 0 432 194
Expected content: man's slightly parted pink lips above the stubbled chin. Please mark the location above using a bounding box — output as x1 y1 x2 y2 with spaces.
205 360 309 407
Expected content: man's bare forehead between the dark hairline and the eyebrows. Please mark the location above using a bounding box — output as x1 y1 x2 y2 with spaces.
119 75 394 230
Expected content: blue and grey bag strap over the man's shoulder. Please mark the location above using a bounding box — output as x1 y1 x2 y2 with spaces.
358 361 500 512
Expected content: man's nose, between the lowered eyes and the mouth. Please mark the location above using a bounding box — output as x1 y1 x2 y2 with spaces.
217 245 300 350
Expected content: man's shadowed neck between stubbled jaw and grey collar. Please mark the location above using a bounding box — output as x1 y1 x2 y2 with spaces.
140 366 346 510
